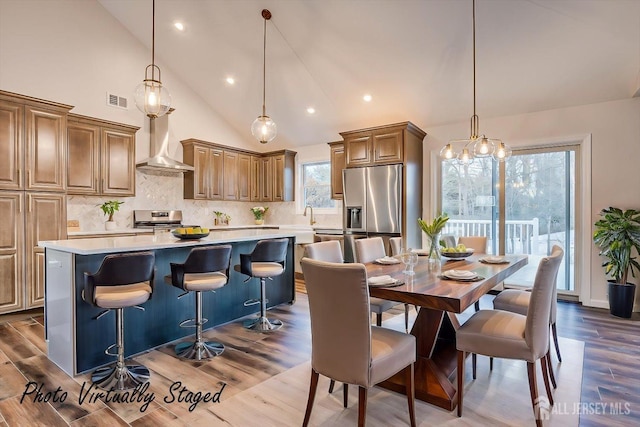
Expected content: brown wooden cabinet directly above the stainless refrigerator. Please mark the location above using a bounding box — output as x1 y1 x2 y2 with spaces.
340 122 426 168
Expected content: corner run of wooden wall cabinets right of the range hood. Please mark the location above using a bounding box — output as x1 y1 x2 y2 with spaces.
182 139 296 202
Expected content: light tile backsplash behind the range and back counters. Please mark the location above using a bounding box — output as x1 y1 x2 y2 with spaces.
67 171 342 231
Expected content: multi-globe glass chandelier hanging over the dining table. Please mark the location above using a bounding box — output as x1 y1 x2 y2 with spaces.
440 0 511 165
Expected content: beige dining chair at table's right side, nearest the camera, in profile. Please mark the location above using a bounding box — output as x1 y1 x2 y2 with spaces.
456 246 563 427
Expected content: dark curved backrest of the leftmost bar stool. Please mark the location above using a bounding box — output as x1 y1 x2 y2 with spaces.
84 252 155 304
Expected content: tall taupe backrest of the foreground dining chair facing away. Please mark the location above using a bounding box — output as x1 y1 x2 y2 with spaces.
300 258 371 387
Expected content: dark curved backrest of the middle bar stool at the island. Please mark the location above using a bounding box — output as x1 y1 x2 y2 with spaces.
170 245 231 287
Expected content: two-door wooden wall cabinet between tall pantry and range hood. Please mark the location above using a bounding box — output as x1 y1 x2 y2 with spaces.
67 114 139 196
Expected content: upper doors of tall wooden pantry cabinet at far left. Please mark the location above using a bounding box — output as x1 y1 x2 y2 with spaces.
0 91 72 192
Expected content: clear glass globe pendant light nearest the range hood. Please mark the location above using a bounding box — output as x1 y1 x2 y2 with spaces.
134 0 171 118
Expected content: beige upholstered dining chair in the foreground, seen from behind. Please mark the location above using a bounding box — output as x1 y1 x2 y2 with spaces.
300 258 416 426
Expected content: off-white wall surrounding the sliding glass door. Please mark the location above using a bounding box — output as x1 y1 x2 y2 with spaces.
424 98 640 307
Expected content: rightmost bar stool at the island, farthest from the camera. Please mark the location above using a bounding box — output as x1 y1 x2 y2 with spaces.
233 238 289 332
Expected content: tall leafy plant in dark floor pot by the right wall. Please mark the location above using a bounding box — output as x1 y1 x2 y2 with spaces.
593 207 640 318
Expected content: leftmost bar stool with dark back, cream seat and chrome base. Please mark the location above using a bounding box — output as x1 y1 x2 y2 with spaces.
82 252 155 390
